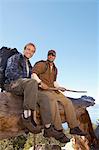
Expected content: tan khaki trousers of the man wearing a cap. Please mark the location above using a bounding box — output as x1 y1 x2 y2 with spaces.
39 90 78 130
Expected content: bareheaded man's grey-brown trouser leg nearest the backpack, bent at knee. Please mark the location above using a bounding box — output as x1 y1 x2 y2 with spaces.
5 78 38 111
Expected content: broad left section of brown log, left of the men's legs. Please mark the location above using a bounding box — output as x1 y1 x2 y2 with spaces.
0 92 23 139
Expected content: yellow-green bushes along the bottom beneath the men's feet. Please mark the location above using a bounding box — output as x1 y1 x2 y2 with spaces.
0 130 70 150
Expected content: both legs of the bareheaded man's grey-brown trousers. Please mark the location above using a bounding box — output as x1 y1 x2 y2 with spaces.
5 78 52 125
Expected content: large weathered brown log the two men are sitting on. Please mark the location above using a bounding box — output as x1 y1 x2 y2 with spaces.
0 92 95 145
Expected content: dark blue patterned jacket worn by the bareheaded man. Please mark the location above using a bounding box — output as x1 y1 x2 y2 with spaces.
5 53 32 83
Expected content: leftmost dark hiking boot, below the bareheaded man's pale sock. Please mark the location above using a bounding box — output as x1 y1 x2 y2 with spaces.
22 117 42 134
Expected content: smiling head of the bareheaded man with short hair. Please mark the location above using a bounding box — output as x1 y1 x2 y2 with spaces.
23 43 36 59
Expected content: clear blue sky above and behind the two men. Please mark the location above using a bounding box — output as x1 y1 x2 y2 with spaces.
0 0 99 103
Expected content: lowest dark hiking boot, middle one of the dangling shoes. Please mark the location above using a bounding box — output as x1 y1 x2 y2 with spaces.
44 125 70 143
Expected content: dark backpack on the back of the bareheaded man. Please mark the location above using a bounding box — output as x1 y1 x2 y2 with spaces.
0 47 19 91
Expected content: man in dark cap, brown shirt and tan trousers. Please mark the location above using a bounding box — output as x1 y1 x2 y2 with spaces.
32 50 85 137
